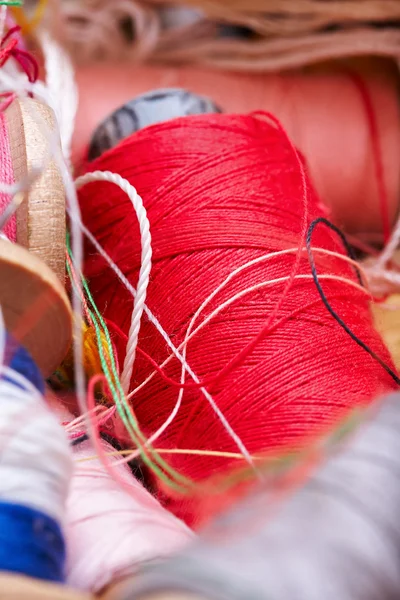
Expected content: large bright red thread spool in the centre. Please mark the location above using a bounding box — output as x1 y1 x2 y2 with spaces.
80 115 395 524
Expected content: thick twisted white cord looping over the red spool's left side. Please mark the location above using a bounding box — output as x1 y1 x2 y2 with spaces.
75 171 152 394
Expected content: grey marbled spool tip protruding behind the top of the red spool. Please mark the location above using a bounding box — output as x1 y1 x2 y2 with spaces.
88 88 221 160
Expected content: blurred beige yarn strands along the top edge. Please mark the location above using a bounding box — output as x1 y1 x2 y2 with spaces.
53 0 400 71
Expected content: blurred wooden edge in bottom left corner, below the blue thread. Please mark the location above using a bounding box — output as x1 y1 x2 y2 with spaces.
0 573 94 600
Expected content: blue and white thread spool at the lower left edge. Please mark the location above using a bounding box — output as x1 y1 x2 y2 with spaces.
0 330 72 582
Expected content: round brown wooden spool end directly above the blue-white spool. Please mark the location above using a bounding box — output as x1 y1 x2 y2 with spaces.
0 239 72 377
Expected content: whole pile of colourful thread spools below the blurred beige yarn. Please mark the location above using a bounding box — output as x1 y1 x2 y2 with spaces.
0 2 400 600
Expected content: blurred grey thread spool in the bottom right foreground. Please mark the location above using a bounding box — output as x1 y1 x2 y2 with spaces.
103 394 400 600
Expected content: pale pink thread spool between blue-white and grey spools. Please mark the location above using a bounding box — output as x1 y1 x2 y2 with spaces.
63 434 193 593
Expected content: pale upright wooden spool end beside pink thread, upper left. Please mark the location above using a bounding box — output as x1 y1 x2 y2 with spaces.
5 98 66 283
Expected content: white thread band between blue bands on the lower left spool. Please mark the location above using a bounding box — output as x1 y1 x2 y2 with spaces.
0 365 72 523
